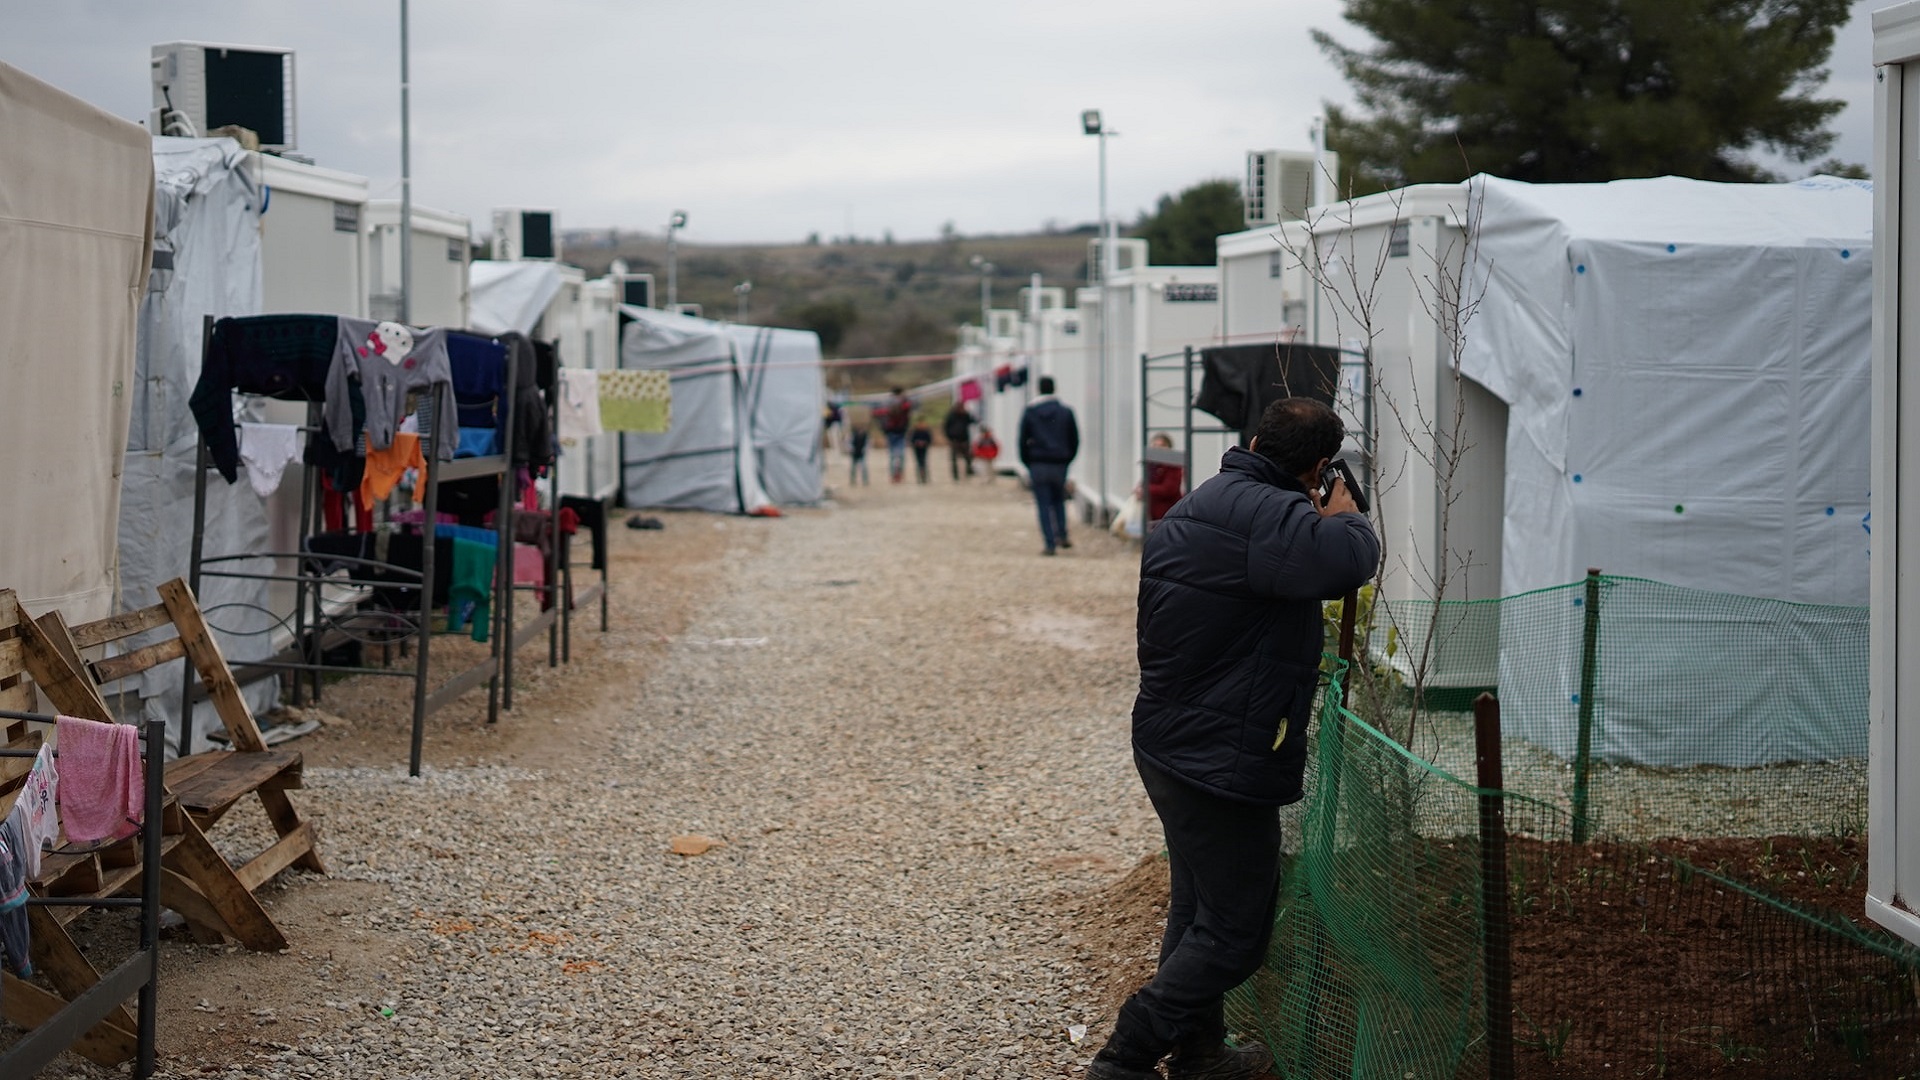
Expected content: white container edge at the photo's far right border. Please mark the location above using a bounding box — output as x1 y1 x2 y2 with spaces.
1866 2 1920 944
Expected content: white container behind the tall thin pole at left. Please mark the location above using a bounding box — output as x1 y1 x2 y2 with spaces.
365 200 472 327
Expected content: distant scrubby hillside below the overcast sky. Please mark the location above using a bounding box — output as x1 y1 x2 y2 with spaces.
566 229 1091 390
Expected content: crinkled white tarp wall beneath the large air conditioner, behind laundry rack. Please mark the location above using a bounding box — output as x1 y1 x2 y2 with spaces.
119 138 280 748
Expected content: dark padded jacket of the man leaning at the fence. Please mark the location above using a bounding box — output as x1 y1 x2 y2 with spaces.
1133 448 1380 805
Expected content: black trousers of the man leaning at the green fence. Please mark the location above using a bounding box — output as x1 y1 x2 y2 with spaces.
1108 755 1281 1067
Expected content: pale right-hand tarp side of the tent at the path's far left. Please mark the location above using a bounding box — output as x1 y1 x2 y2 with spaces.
728 325 828 505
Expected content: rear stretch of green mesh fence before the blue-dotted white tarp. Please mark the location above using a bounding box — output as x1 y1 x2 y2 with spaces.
1354 575 1868 840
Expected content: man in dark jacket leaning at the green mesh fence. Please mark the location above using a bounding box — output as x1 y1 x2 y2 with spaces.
1087 398 1380 1080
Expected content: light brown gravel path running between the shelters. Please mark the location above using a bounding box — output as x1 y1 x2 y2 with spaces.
101 472 1160 1078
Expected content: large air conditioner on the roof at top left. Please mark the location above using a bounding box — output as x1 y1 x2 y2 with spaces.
148 40 298 152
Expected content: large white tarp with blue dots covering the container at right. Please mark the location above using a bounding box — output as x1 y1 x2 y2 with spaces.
1463 177 1872 765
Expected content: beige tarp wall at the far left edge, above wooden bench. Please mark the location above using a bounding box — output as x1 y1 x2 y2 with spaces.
0 63 151 621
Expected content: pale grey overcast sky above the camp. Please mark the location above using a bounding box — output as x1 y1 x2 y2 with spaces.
0 0 1891 244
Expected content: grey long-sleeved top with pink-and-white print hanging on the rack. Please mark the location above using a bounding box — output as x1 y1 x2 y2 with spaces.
324 317 459 461
